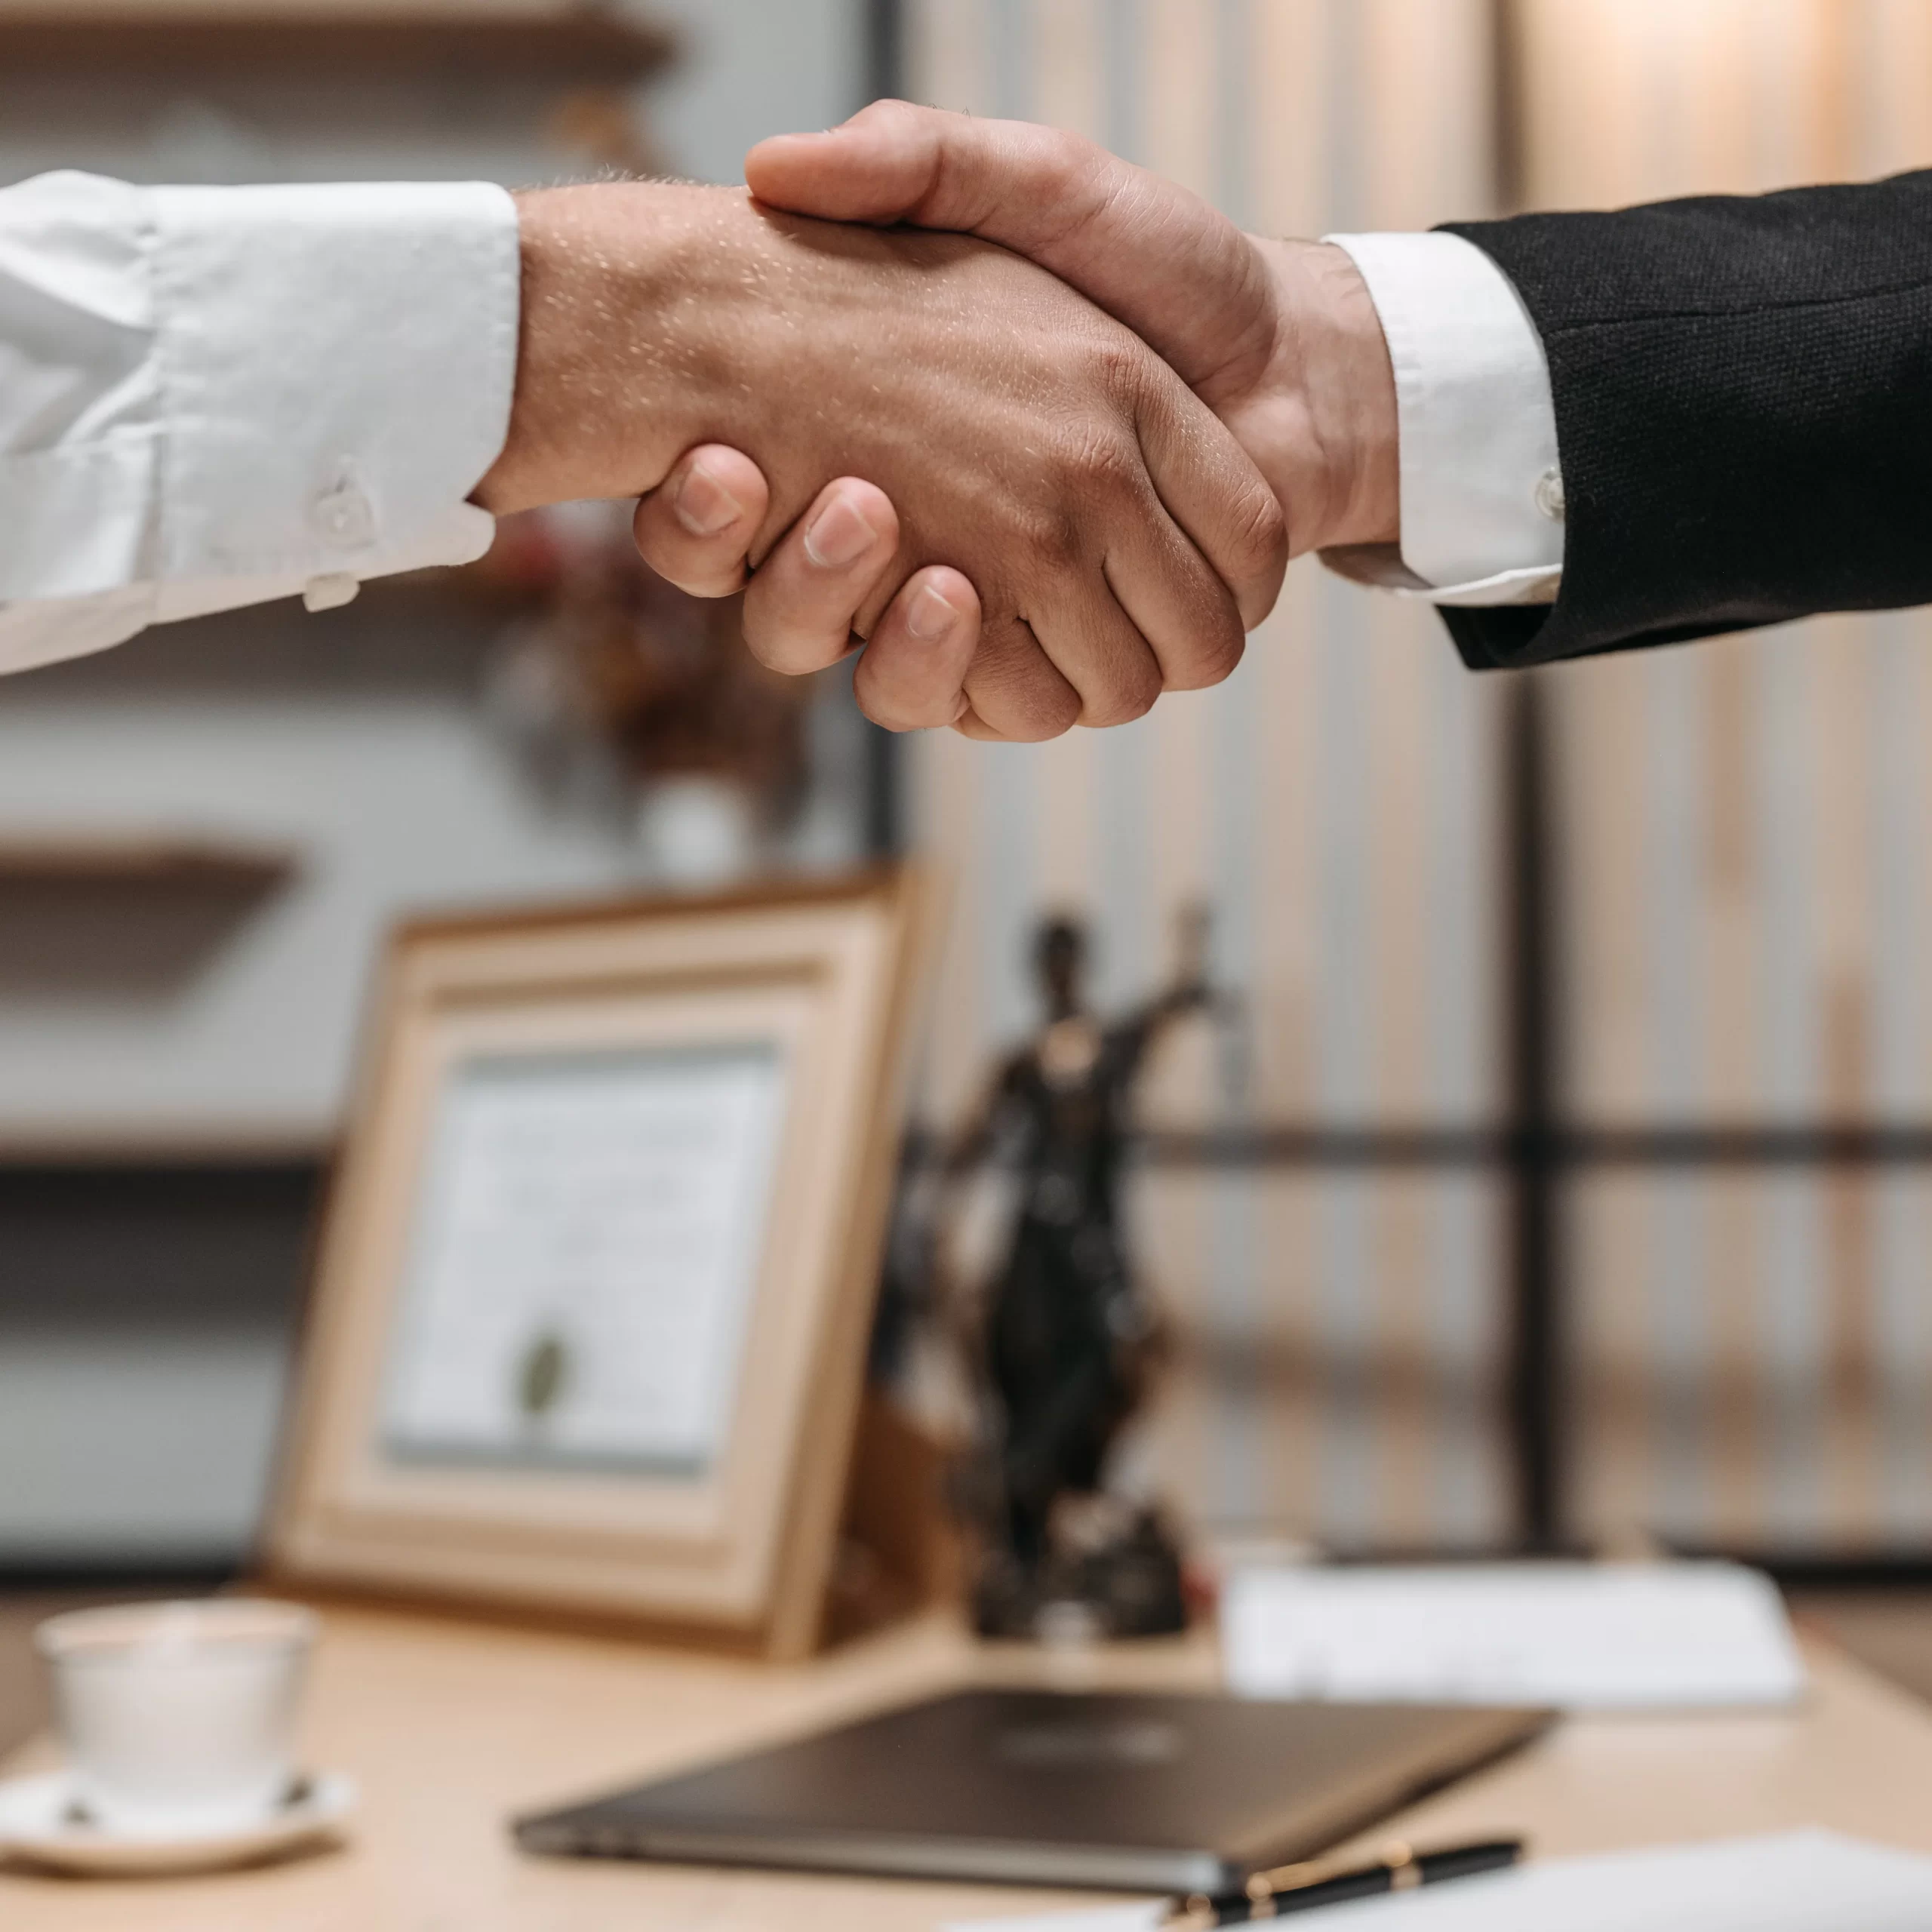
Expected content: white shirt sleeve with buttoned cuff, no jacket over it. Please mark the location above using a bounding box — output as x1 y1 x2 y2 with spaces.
0 174 520 670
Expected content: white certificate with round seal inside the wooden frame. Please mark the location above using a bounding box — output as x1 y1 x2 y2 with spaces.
383 1041 784 1474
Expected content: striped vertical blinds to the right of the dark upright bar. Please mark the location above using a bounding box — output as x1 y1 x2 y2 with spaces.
1517 0 1932 1549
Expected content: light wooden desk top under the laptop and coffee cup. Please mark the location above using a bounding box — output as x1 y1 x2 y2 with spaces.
0 1611 1932 1932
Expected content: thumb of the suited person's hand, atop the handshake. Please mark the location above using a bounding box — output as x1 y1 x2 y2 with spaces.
744 100 1275 401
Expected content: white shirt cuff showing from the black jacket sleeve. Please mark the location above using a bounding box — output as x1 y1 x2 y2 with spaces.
1324 234 1563 605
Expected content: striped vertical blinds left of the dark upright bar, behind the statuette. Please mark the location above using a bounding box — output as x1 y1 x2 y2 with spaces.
910 0 1509 1543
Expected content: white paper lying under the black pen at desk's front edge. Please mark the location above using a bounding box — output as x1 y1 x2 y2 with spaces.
945 1832 1932 1932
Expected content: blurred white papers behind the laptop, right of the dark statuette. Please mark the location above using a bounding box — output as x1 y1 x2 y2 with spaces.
1221 1563 1804 1710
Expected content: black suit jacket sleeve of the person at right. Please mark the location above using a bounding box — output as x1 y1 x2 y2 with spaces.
1443 172 1932 669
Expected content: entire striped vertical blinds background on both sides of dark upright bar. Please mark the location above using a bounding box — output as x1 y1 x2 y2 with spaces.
912 0 1932 1549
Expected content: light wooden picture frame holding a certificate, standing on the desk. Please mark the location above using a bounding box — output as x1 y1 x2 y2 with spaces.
266 867 929 1656
